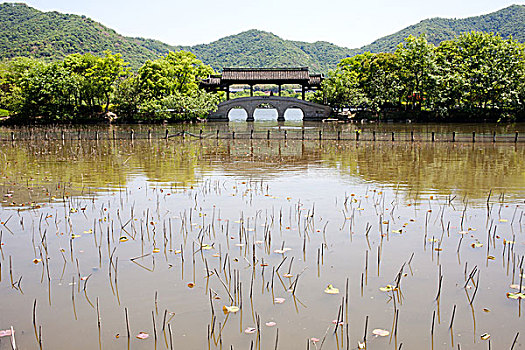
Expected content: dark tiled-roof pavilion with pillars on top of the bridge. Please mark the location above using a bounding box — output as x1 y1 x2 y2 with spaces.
200 67 323 100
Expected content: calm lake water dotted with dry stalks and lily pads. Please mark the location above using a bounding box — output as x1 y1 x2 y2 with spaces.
0 119 525 350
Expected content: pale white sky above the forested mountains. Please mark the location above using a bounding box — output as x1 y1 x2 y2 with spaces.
2 0 525 48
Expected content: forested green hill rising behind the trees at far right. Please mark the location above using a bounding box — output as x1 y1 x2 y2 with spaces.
359 5 525 52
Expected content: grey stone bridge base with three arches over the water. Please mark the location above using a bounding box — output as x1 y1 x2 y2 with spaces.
208 96 331 121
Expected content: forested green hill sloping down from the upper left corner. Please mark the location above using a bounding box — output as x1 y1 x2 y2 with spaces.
0 3 177 67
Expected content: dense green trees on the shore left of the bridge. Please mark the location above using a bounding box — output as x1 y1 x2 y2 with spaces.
0 51 219 124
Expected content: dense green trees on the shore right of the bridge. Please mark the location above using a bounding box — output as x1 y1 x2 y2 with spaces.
315 32 525 121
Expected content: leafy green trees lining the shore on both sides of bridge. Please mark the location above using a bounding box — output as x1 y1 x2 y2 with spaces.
0 32 525 125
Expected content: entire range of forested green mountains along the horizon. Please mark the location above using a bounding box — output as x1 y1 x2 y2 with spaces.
0 3 525 72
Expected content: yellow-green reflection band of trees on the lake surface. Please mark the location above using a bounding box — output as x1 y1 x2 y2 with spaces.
0 135 525 204
